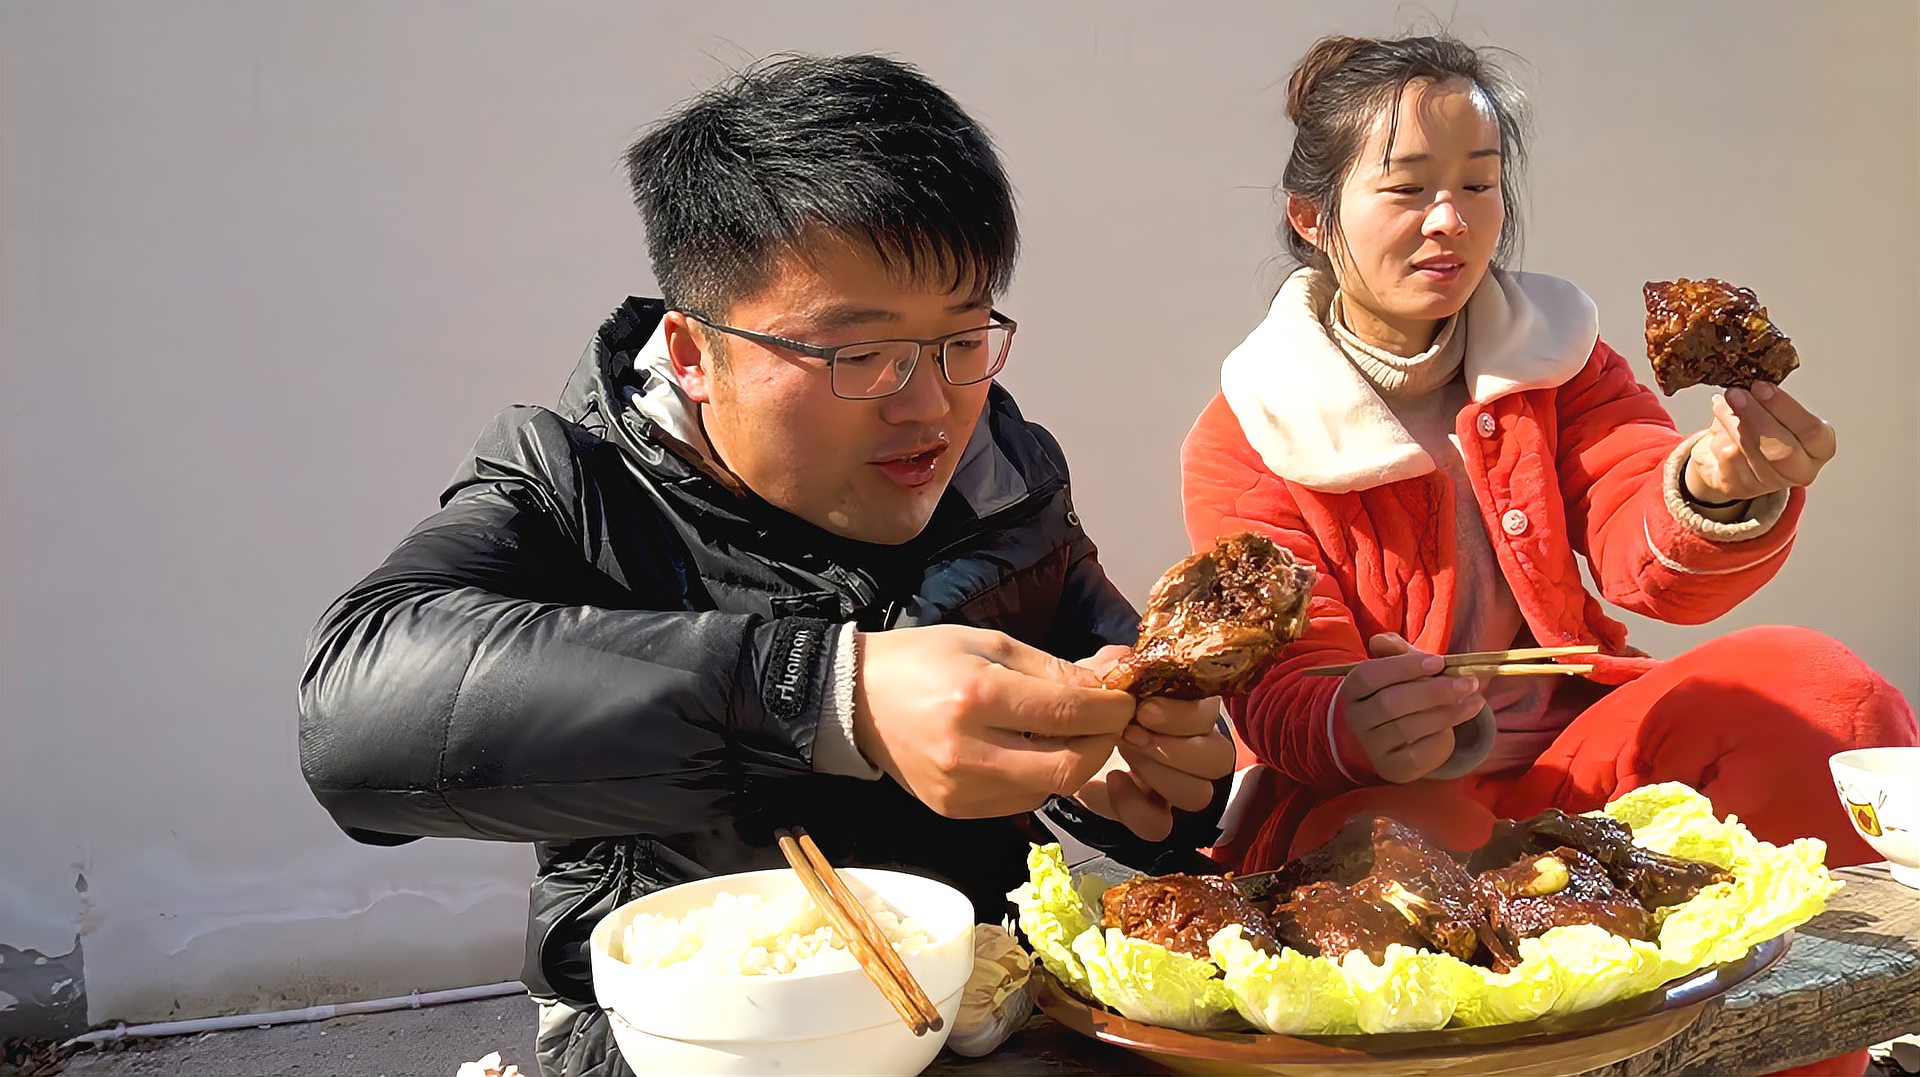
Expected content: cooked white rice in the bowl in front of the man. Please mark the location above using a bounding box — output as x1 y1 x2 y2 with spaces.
622 877 933 975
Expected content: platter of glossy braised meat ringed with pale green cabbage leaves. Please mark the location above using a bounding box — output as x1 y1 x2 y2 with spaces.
1012 783 1837 1073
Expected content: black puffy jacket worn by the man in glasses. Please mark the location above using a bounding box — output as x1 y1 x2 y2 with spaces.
300 299 1213 1052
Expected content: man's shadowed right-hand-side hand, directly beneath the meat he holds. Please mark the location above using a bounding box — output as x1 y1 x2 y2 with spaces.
1073 647 1233 841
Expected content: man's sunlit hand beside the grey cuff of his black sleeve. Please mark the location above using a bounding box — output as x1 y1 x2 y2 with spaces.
852 624 1133 818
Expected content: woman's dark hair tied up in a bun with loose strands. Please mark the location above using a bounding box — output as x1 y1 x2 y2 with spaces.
1281 36 1526 269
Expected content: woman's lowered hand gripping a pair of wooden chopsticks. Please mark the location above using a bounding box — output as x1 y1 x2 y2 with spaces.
1340 635 1486 781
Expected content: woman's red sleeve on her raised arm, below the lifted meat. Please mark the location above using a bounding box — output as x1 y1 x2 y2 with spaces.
1553 342 1807 624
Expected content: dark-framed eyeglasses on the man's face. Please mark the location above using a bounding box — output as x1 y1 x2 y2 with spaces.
680 311 1020 399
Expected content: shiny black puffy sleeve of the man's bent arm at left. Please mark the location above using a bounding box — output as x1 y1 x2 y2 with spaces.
300 409 837 843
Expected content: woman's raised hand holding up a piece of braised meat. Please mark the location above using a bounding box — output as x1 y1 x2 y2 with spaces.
1686 382 1839 505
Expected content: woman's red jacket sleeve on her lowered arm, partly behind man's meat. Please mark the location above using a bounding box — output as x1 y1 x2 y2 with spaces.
1181 397 1379 789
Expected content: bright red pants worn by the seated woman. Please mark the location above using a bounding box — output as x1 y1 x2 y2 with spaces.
1213 628 1920 1075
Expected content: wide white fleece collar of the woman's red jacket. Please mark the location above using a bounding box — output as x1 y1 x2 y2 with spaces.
1219 269 1599 493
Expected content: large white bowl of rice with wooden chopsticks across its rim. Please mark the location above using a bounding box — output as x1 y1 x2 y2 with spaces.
591 868 973 1075
